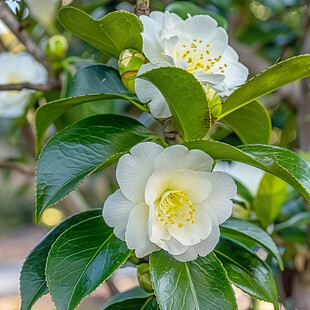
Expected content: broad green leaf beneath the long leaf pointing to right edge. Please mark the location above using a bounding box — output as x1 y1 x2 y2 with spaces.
221 101 271 144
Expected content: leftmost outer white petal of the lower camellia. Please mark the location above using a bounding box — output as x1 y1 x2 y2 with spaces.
102 189 135 240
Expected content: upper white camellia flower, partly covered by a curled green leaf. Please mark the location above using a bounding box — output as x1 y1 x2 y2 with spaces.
135 12 248 118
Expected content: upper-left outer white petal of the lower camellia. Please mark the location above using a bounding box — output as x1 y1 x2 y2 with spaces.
116 142 163 204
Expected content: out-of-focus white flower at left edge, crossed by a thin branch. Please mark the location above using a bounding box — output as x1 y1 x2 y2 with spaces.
0 52 48 118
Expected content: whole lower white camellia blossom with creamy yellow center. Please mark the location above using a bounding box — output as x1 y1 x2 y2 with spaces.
103 142 237 261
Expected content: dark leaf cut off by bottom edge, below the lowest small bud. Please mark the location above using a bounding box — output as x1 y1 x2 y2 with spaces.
102 287 159 310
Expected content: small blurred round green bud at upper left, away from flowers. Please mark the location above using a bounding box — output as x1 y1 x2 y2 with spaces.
45 35 68 62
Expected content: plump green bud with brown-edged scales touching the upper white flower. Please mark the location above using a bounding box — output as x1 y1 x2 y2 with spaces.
118 48 146 94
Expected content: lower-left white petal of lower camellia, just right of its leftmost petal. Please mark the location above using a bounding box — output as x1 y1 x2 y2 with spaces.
125 203 159 257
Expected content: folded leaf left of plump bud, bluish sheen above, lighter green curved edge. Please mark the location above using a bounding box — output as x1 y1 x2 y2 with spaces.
35 64 143 153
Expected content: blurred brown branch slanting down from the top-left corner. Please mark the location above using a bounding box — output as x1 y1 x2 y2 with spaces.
0 2 49 70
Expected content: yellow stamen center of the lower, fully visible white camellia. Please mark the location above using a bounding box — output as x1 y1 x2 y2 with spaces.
156 191 196 228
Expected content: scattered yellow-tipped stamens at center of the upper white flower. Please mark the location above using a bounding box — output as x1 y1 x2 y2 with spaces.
178 39 227 74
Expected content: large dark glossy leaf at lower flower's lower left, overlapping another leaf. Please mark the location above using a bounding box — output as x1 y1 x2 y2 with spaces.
46 215 131 310
